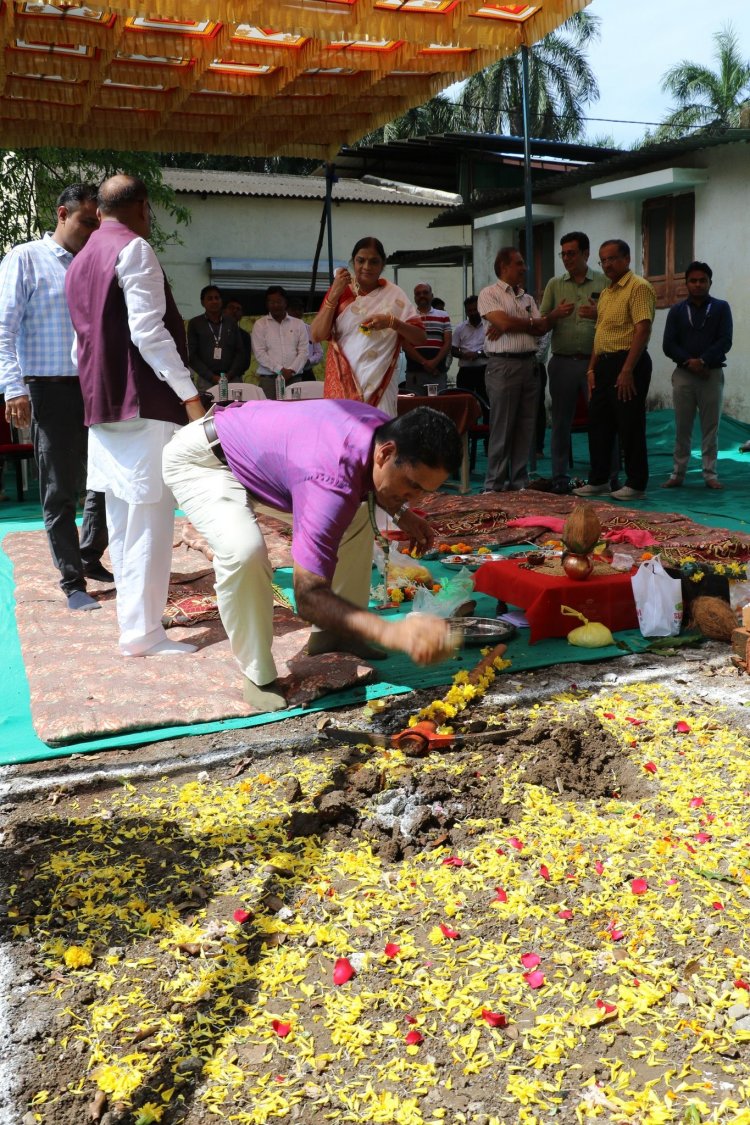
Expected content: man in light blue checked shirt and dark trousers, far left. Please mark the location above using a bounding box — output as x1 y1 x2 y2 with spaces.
0 183 114 610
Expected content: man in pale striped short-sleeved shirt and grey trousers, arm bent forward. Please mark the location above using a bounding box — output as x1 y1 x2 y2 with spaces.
478 246 573 492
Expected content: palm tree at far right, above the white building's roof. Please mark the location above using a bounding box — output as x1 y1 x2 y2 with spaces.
657 24 750 140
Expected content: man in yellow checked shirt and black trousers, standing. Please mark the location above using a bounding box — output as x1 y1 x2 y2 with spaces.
575 239 656 501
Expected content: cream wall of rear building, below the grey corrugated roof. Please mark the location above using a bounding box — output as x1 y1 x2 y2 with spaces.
161 195 472 322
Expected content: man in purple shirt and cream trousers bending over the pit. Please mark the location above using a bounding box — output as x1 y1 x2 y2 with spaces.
164 399 461 711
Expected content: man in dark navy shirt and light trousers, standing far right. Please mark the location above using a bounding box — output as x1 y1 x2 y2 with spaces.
661 262 732 488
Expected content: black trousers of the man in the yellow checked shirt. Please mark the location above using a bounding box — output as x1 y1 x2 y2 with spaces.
588 351 651 491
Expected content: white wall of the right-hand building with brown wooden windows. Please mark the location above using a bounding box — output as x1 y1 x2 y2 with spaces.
473 144 750 422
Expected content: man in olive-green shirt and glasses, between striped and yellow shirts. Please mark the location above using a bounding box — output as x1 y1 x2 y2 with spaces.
540 231 607 495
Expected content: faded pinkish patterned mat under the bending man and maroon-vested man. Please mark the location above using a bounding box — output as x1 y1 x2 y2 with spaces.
3 519 372 746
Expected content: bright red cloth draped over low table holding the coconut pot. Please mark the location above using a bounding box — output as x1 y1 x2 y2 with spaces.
475 559 638 645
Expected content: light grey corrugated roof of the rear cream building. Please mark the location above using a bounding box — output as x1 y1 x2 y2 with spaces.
163 168 461 207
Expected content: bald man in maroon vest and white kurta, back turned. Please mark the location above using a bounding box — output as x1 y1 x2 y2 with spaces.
65 176 205 656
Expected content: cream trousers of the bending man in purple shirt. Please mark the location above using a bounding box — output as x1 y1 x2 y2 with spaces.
163 418 373 685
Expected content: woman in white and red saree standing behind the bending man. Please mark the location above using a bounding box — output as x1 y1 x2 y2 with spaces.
310 236 426 416
